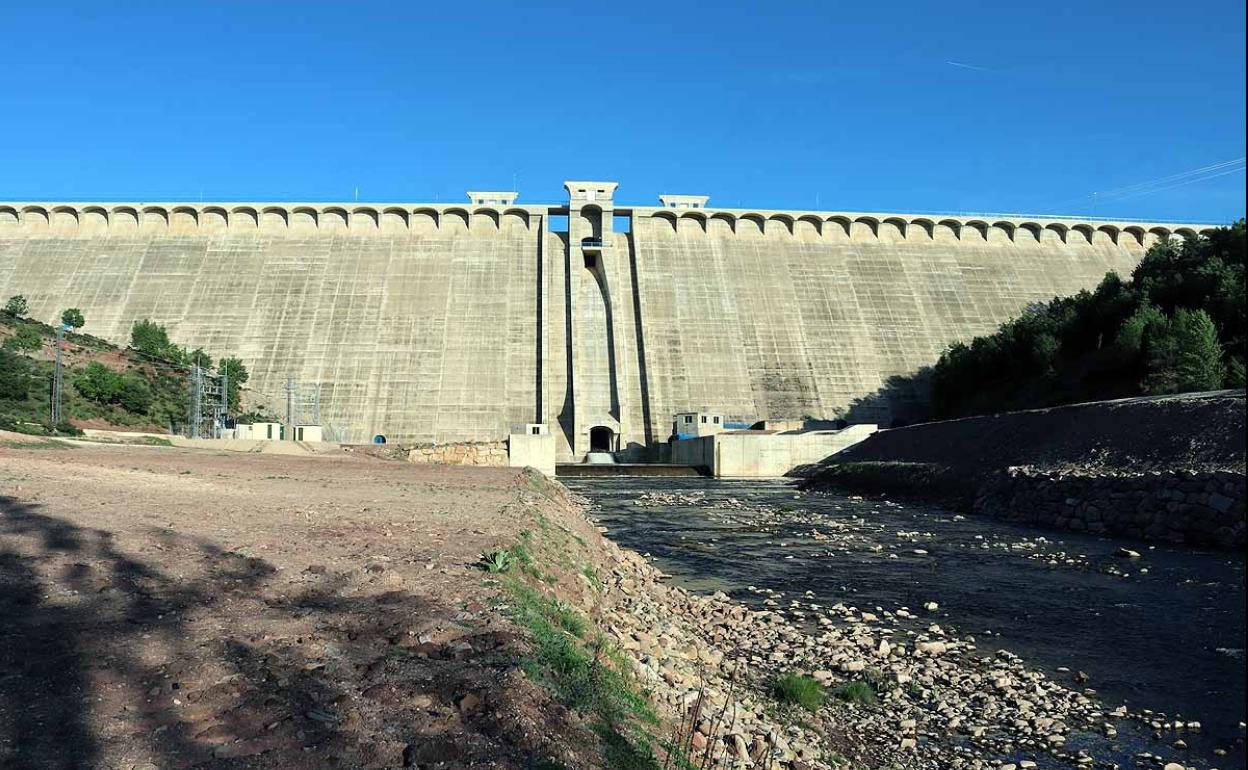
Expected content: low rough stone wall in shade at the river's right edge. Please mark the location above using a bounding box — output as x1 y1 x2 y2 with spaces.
975 468 1246 548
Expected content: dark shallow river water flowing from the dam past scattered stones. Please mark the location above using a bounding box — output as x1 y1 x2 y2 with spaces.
562 478 1246 770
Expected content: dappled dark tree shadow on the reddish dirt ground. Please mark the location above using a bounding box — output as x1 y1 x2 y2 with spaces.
0 495 584 770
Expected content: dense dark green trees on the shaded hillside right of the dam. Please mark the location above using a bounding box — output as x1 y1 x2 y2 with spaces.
930 220 1248 419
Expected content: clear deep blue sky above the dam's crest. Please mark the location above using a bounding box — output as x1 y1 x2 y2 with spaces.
0 0 1244 221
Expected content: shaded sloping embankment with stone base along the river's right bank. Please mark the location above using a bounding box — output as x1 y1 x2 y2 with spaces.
801 391 1246 548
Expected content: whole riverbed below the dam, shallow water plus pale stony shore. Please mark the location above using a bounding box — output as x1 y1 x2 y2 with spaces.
570 479 1243 770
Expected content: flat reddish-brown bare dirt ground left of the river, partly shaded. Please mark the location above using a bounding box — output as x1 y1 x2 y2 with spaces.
0 433 604 770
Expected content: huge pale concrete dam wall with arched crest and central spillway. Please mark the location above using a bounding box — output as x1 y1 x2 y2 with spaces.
0 181 1201 462
